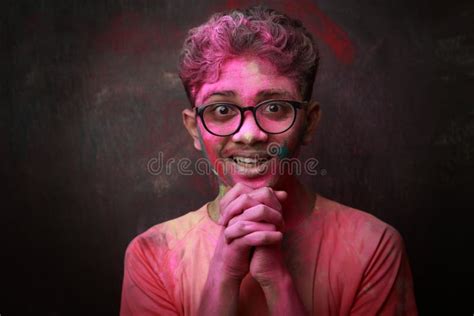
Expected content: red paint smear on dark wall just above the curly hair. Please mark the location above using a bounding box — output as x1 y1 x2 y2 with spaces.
226 0 355 64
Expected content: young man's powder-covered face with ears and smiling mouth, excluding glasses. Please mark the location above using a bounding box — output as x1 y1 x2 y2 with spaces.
183 57 319 188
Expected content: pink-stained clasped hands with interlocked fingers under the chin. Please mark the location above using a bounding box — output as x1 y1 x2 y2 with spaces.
214 183 287 286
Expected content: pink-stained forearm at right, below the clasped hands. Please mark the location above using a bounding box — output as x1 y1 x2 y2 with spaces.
262 272 307 316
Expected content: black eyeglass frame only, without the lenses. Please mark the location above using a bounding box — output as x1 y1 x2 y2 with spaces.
195 99 308 137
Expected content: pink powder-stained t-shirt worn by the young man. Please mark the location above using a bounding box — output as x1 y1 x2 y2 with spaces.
121 195 417 316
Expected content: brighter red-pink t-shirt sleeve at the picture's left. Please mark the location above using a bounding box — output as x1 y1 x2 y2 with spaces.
120 237 179 316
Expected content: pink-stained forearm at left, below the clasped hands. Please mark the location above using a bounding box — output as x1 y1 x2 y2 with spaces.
198 271 241 315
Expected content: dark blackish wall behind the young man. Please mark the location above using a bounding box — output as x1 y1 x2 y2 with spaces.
0 0 474 316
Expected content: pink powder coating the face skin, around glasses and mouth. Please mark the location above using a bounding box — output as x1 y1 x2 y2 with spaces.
196 56 304 188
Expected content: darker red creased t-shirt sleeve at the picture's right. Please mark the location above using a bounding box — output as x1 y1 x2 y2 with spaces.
351 226 417 316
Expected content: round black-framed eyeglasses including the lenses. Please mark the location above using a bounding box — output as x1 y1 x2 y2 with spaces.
196 100 307 136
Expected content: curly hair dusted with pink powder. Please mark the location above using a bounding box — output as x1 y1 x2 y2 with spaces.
179 6 319 105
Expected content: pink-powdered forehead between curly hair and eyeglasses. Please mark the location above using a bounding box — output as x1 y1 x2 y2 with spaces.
196 57 298 104
